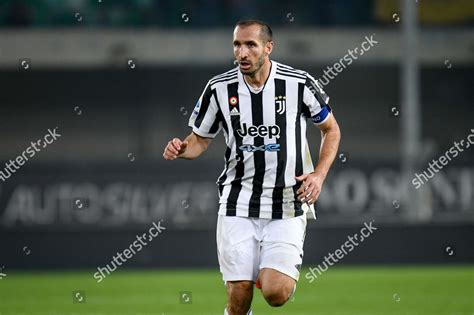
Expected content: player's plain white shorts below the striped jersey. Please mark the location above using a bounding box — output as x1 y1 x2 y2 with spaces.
216 215 306 282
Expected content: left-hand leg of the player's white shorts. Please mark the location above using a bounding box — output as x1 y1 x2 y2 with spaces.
216 215 260 282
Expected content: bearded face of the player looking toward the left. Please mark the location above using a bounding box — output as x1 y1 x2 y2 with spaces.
234 25 273 76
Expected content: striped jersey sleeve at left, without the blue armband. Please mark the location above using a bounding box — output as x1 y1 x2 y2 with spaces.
188 83 222 138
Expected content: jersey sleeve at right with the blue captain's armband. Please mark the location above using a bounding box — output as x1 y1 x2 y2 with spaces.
303 74 332 125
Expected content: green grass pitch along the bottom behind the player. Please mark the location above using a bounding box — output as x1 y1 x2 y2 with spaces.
0 266 474 315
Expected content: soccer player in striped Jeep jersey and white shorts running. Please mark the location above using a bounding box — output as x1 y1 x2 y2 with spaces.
163 20 340 315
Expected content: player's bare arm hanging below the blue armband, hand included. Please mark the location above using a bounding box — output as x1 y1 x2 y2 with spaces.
296 114 341 204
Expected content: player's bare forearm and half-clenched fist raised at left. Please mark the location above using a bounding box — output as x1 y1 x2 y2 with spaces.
163 132 212 161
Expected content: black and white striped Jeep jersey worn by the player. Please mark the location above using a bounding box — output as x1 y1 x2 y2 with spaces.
189 61 331 219
